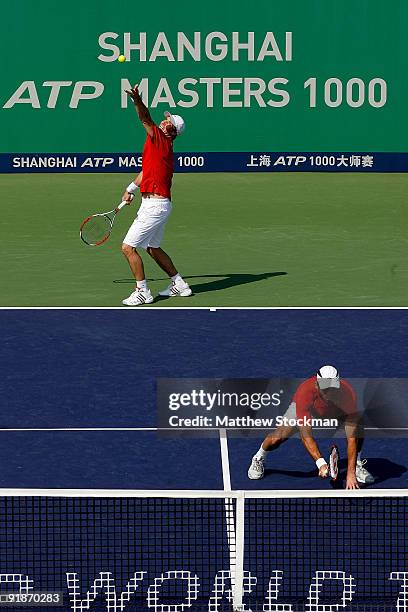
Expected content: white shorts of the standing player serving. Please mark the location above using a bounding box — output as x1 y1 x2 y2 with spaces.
123 198 171 249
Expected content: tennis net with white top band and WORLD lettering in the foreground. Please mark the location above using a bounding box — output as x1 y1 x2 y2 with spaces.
0 490 408 612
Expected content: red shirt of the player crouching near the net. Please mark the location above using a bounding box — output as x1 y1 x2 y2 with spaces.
293 376 358 419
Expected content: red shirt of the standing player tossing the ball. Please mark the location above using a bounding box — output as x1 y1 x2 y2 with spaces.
140 125 173 199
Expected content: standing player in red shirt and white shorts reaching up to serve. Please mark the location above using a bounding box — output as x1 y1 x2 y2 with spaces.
122 85 192 306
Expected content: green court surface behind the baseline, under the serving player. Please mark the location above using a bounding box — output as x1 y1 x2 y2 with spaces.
0 173 408 308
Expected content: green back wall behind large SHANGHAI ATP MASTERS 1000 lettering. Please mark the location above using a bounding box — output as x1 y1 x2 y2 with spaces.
0 0 408 153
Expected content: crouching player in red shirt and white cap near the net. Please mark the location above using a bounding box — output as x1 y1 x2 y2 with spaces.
248 365 374 489
